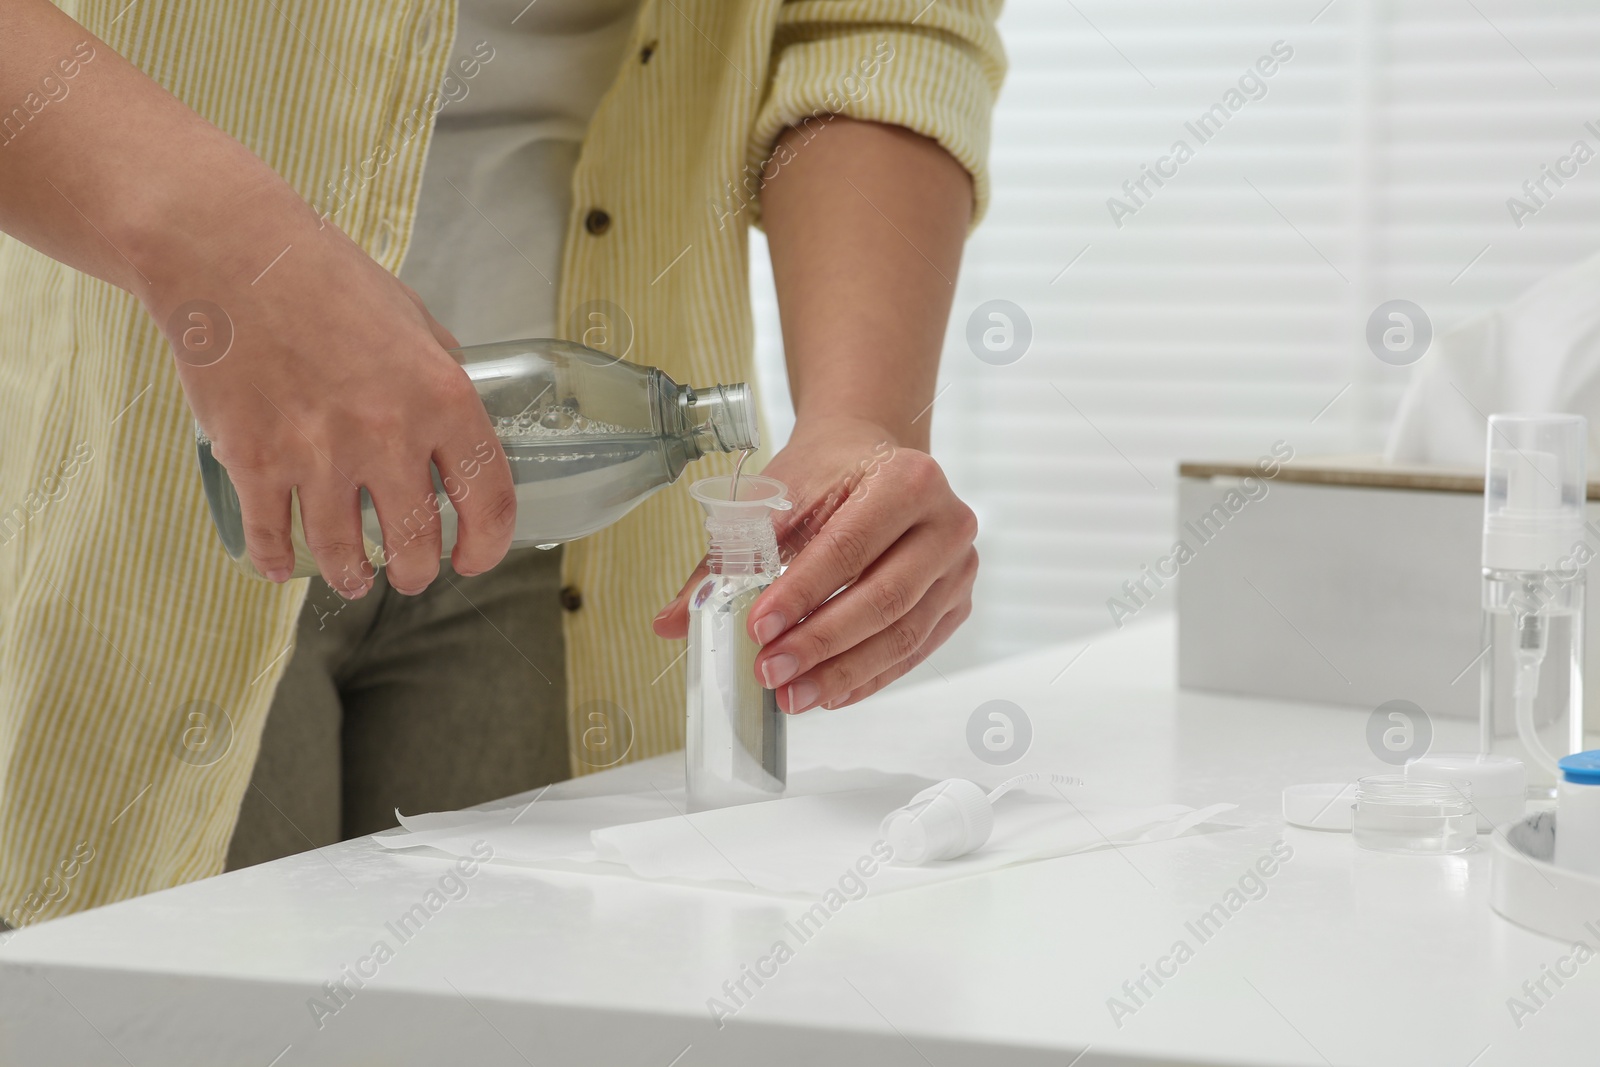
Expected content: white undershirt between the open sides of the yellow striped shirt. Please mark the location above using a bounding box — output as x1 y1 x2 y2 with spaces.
400 0 640 344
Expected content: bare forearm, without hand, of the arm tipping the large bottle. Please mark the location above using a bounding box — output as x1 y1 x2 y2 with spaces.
0 0 291 306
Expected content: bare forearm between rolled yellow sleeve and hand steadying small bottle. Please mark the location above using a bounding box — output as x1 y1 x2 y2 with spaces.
762 117 973 450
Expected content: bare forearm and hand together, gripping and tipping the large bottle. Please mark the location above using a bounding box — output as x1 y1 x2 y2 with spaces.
0 0 517 598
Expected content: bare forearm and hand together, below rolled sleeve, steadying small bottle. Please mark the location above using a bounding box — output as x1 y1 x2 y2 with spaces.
672 115 978 713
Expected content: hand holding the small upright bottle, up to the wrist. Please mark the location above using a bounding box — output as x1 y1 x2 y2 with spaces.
656 418 978 713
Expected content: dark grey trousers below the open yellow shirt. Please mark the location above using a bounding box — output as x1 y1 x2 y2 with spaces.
227 549 570 870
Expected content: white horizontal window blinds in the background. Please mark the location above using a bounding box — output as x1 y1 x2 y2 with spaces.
755 0 1600 672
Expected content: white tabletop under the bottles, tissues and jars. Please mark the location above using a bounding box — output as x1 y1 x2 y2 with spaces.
0 622 1600 1067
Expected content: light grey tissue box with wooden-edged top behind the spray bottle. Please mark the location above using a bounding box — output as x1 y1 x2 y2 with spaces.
1171 456 1600 731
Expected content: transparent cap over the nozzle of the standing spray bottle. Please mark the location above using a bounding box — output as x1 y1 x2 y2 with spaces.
1483 414 1589 571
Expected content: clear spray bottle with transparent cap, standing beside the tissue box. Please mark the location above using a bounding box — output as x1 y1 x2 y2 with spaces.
1478 414 1587 798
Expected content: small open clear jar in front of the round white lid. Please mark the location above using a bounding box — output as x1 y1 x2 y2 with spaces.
1352 774 1478 856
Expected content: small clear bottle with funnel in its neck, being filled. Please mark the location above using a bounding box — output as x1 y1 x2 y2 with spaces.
683 475 792 811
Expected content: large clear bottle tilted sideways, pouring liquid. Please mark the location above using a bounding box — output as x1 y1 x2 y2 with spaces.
195 339 760 577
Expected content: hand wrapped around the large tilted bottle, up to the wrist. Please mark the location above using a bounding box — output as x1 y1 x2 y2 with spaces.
142 182 517 598
